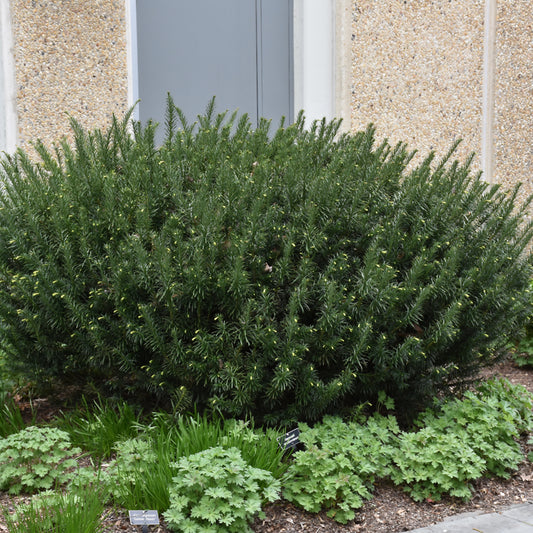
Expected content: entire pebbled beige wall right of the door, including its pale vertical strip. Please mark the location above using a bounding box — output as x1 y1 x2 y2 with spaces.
351 0 533 214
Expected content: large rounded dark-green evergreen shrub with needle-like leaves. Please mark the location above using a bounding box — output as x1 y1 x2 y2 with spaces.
0 100 532 422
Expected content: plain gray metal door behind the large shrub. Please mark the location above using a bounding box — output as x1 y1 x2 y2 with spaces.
136 0 293 135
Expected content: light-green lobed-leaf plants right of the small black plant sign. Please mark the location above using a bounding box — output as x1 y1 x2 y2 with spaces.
283 380 533 523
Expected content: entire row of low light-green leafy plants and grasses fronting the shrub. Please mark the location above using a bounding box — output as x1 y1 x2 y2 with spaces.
0 374 533 532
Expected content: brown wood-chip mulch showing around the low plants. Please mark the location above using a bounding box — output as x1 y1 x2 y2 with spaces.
0 360 533 533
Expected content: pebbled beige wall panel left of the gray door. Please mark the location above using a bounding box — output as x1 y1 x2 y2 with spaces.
11 0 128 148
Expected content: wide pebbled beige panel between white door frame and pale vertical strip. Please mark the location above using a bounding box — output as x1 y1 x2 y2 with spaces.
352 0 484 168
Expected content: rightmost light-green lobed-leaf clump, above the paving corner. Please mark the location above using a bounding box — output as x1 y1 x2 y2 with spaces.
391 380 533 501
